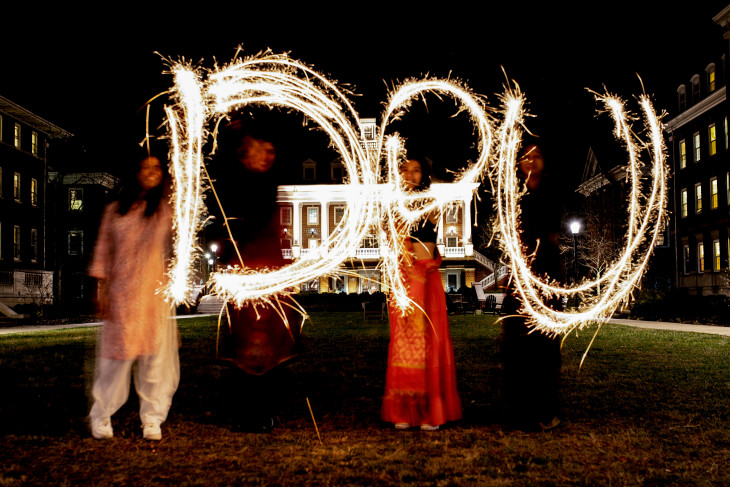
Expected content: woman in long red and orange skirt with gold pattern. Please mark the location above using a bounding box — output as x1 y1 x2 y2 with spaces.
382 159 461 431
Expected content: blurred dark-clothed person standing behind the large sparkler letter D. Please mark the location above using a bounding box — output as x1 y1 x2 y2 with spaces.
208 120 303 432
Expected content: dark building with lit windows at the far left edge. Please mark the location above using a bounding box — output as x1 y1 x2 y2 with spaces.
0 97 71 305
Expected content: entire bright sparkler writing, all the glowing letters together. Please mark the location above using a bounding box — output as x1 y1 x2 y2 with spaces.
166 53 667 334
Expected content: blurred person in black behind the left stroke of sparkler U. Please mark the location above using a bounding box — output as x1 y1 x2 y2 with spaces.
500 144 563 431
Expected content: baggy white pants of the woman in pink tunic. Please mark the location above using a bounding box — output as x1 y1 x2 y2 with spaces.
89 317 180 425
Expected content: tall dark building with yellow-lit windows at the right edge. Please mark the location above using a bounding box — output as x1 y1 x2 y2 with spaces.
665 6 730 295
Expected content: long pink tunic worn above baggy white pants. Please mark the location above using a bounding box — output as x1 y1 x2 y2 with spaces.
89 202 171 360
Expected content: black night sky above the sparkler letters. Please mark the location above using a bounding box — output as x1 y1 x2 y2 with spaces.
0 1 725 191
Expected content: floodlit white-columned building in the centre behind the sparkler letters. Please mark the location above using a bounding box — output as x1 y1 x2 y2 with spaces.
270 119 498 293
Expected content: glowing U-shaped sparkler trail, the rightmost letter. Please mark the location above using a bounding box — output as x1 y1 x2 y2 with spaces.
492 90 668 334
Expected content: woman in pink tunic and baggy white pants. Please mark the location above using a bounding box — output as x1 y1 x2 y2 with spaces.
89 156 180 440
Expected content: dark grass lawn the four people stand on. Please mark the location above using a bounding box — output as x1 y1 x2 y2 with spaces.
0 313 730 486
